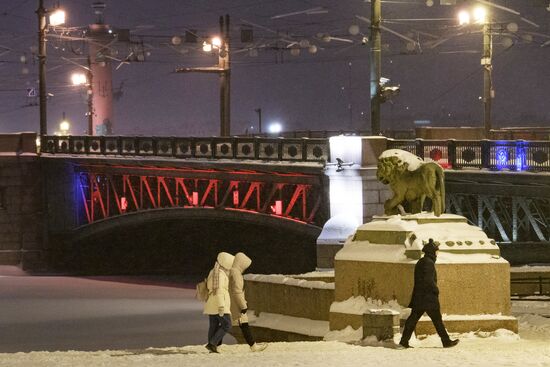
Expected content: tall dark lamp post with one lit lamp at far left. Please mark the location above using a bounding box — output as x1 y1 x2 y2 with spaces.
36 0 65 141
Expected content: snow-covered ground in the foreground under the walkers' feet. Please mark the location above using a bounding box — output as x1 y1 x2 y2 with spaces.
0 298 550 367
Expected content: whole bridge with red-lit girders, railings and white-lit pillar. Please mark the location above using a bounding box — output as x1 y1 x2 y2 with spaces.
0 136 550 271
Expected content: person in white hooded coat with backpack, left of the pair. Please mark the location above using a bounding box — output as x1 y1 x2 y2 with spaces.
203 252 235 353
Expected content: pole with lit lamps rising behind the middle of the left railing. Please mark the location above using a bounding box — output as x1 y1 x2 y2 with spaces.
218 14 231 136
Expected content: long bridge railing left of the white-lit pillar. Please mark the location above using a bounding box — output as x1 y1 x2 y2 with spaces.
41 135 330 162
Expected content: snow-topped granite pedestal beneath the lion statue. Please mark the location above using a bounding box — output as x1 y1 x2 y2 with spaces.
330 213 517 333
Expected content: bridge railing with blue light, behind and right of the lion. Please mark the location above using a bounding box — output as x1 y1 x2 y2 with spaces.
387 139 550 171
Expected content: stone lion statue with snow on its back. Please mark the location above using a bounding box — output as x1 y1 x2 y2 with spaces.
376 149 445 217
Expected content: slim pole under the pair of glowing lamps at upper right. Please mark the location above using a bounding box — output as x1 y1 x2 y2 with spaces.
481 21 495 139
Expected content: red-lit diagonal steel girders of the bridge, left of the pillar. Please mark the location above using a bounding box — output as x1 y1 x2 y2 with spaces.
77 165 325 226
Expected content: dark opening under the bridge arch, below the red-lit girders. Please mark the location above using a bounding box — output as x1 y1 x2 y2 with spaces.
64 208 321 278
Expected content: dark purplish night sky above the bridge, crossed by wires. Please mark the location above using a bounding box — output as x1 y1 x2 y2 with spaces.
0 0 550 136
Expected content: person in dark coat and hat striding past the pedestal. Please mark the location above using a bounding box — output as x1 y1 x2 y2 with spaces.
399 238 458 348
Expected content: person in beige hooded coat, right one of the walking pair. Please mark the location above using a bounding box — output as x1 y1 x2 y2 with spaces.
229 252 267 352
